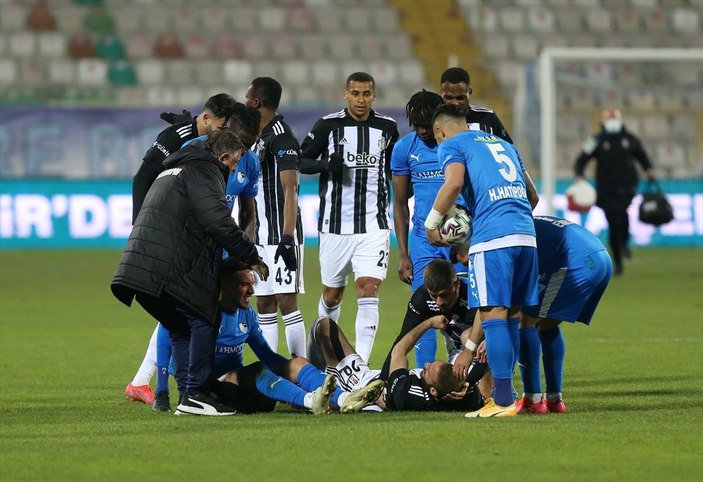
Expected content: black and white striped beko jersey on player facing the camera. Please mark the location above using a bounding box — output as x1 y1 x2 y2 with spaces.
301 109 398 234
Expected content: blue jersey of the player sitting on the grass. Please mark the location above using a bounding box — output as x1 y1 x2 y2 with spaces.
211 307 287 378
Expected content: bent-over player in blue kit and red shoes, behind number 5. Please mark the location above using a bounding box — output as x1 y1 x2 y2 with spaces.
451 216 613 413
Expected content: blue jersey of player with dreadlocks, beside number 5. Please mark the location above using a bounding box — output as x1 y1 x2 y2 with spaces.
391 132 444 238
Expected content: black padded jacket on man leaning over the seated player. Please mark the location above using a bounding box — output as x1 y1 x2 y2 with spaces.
112 141 259 323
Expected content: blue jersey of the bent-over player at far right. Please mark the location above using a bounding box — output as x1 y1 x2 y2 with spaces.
535 216 605 274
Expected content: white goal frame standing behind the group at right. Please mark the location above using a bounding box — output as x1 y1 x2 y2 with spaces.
539 47 703 214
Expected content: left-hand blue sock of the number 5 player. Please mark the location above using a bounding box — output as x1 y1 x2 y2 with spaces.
481 318 515 407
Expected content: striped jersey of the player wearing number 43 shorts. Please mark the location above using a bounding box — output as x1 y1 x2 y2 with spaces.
252 115 303 246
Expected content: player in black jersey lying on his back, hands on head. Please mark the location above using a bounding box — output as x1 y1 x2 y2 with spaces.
310 315 485 411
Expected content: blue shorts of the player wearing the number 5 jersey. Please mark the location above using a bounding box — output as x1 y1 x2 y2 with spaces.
469 246 539 308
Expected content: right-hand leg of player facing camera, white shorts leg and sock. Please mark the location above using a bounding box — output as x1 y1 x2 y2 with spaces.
352 230 390 363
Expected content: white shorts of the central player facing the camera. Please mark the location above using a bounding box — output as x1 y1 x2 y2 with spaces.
320 229 391 288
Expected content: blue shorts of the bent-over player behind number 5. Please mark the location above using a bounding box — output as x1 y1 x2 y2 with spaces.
522 249 613 325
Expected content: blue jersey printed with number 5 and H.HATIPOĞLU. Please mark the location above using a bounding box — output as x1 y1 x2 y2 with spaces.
438 131 535 253
